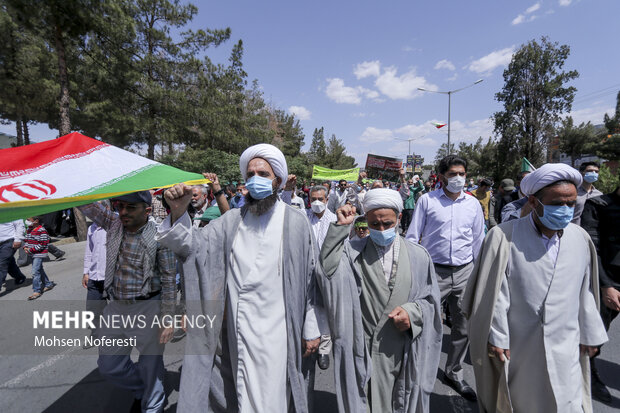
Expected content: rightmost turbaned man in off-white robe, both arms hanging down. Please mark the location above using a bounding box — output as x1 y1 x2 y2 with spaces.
461 164 607 413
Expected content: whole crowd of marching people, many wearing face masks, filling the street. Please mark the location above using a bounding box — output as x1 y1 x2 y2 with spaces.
0 144 620 413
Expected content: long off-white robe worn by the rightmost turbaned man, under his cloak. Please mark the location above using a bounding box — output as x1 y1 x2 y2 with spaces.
489 216 607 413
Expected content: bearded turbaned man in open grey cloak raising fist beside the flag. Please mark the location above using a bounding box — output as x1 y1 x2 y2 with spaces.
158 144 320 412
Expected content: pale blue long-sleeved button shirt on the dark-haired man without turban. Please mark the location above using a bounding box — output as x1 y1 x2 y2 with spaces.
406 189 484 266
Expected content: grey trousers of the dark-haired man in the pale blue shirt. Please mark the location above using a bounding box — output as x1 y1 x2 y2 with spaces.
435 262 474 381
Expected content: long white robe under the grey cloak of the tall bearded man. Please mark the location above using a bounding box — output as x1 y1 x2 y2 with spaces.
226 202 288 412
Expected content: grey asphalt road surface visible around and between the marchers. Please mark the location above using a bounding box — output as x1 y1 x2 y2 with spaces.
0 243 620 413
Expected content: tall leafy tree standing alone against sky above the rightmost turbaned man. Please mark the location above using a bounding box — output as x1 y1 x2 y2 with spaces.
493 37 579 175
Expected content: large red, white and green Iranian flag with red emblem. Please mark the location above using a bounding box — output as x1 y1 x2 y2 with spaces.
0 132 209 222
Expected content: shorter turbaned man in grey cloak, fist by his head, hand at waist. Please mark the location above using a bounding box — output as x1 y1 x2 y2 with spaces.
317 189 442 413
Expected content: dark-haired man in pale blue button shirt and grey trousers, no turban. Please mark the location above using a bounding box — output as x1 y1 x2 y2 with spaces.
406 155 484 401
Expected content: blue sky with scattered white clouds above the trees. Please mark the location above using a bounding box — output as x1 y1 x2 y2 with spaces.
0 0 620 167
